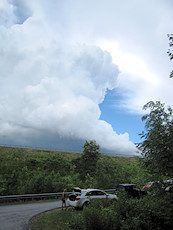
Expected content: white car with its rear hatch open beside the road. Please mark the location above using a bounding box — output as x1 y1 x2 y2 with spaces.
68 189 117 209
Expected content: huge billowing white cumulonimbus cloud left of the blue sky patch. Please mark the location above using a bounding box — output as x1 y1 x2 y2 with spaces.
0 0 136 154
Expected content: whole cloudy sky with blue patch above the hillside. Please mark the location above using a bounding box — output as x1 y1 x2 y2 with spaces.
0 0 173 155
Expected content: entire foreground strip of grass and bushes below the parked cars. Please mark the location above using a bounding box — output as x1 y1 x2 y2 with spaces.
30 190 173 230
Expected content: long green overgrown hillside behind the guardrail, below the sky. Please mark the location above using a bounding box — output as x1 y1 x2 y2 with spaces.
0 147 139 195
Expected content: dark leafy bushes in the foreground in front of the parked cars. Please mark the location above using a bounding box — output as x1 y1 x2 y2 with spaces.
70 190 173 230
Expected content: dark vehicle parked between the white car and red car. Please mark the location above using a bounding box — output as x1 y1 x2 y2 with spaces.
115 184 147 199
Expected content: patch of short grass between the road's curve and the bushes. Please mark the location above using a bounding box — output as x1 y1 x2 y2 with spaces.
29 208 74 230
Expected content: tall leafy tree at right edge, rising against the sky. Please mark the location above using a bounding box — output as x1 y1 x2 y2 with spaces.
138 101 173 178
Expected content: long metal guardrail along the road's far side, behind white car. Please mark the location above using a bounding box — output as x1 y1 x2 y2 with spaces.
0 189 115 201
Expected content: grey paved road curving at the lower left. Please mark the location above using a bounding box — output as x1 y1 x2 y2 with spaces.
0 201 61 230
